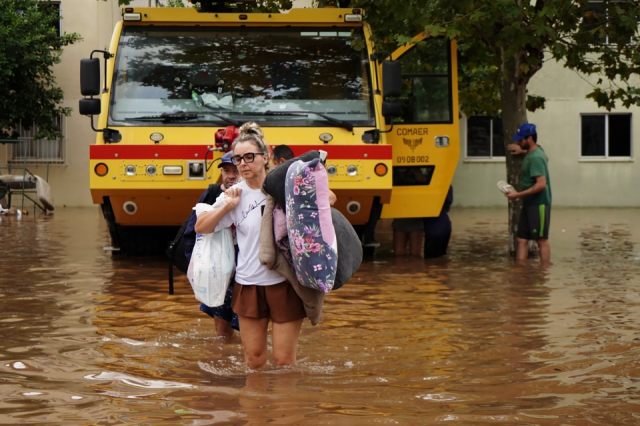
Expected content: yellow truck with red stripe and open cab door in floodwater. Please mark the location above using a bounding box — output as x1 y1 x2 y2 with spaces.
80 7 460 253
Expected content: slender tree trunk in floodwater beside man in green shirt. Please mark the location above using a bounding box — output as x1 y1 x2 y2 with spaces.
500 75 527 257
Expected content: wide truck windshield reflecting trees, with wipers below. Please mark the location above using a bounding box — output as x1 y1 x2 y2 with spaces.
109 26 375 128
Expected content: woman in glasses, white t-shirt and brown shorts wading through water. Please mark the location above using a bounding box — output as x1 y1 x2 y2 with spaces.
195 123 306 370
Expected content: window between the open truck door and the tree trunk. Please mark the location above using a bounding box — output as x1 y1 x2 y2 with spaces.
467 115 505 158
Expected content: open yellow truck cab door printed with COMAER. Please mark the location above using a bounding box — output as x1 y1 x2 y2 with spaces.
381 38 460 218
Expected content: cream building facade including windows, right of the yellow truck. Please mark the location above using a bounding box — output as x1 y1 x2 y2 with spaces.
453 56 640 207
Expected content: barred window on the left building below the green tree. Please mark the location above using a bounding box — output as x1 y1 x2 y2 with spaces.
7 115 66 164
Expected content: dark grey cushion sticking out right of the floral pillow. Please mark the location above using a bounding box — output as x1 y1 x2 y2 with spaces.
331 208 362 290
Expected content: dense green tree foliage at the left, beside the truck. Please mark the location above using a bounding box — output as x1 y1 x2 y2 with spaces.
0 0 81 139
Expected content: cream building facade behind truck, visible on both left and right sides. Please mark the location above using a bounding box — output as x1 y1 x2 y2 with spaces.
0 0 640 208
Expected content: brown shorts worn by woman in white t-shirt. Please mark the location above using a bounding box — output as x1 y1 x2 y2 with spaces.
232 281 307 323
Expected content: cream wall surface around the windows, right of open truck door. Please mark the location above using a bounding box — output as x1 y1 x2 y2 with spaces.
453 55 640 207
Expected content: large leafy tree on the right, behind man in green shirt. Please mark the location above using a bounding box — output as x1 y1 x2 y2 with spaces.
354 0 640 252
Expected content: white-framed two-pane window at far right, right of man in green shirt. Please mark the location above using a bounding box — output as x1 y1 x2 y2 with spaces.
580 114 631 158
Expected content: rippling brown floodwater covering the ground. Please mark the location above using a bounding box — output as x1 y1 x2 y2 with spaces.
0 208 640 426
